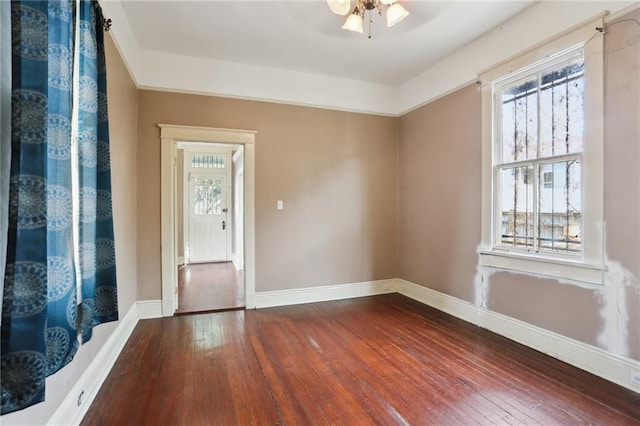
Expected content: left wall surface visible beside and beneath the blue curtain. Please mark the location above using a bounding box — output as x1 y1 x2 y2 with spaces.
2 35 138 426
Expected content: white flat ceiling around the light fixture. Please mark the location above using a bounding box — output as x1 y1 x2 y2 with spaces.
122 0 533 86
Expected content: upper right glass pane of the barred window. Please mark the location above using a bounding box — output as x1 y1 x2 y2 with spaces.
540 61 584 157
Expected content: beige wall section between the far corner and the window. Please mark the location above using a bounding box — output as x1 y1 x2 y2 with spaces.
399 86 481 301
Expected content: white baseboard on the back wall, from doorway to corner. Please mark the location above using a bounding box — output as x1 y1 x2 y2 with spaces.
256 279 396 309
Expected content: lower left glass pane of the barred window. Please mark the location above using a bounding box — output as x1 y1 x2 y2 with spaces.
499 166 534 248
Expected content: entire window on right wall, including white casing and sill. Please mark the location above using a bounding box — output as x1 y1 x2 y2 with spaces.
478 22 605 284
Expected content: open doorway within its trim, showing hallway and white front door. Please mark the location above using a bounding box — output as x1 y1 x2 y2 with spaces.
176 142 245 314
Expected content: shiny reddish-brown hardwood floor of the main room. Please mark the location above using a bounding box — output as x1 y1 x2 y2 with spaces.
82 294 640 425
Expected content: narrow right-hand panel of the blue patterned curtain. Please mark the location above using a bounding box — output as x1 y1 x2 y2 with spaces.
78 0 118 342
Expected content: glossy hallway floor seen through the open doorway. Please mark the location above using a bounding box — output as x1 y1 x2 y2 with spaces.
176 262 244 314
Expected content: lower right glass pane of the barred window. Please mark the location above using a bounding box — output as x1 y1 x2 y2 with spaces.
537 159 582 253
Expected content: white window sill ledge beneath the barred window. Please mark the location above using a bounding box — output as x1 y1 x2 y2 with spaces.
478 249 607 285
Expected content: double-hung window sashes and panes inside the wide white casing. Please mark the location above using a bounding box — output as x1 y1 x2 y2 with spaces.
493 49 584 255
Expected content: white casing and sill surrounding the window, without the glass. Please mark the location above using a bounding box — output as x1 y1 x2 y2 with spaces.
478 18 606 284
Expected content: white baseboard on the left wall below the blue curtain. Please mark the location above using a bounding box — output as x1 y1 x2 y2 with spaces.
47 303 138 426
